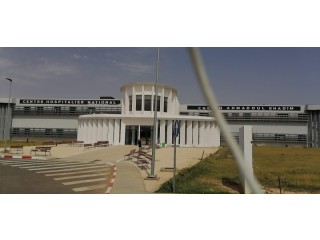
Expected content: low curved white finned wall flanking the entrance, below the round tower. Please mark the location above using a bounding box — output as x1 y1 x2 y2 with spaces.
78 115 220 147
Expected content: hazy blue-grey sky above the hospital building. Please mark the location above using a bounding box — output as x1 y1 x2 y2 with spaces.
0 47 320 104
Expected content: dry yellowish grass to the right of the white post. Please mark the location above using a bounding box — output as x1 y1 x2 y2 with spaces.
253 147 320 193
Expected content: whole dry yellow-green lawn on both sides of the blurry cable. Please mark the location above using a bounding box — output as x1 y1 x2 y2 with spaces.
157 147 320 194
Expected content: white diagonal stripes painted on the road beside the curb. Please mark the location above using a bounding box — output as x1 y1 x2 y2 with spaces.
0 159 113 193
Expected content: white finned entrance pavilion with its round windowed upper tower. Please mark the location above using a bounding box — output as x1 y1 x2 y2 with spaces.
77 83 220 147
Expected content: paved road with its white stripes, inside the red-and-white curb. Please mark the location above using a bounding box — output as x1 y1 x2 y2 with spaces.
0 159 113 194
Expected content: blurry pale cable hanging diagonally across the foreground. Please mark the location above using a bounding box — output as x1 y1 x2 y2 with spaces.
189 48 262 193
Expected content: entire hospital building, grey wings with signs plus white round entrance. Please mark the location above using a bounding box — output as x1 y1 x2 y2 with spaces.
0 82 320 147
